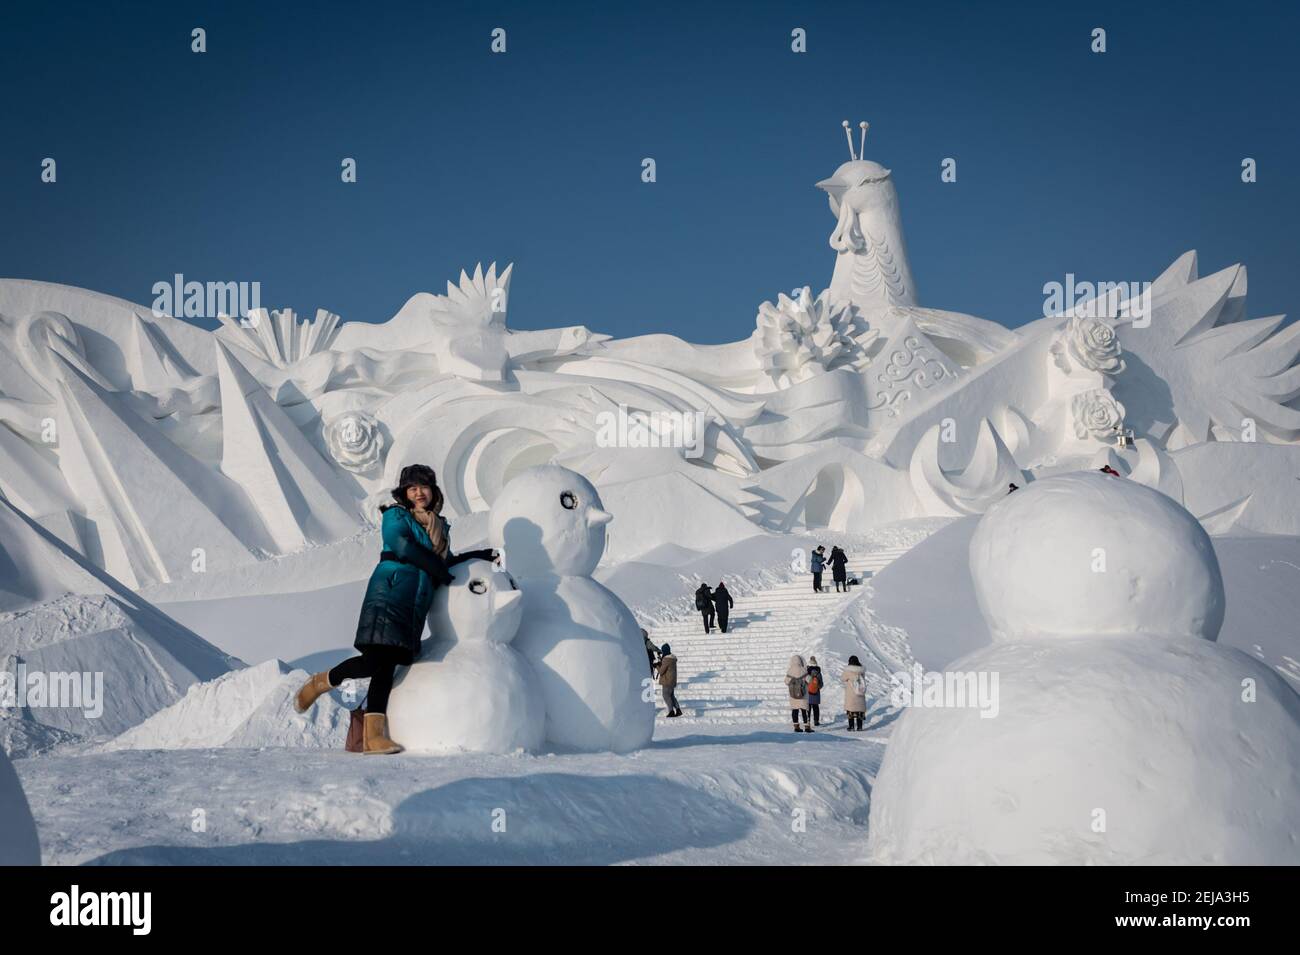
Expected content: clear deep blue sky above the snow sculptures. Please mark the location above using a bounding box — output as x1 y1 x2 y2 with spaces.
0 0 1300 342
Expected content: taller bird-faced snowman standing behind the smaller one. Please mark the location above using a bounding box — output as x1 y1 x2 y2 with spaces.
489 465 654 752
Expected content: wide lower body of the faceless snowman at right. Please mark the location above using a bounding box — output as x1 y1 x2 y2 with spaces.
867 635 1300 865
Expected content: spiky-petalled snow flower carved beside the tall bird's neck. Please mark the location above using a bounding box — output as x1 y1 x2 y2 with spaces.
751 286 878 388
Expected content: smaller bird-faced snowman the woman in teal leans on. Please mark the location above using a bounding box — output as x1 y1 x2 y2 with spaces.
389 560 546 754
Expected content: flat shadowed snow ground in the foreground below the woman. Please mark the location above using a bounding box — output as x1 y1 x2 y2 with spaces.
14 717 891 865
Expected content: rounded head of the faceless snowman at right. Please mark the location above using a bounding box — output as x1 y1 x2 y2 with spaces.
970 472 1225 641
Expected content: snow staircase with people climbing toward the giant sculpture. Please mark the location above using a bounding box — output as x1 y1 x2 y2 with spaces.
650 547 910 722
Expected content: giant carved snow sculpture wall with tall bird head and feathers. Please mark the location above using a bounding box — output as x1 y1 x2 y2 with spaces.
0 123 1300 586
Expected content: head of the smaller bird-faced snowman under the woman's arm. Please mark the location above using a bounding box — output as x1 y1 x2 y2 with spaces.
429 560 524 646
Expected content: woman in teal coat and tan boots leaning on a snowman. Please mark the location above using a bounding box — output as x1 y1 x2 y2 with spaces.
295 464 498 754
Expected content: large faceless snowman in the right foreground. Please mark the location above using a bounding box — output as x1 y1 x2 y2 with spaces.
867 472 1300 865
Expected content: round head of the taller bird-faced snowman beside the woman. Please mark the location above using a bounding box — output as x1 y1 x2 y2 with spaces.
488 464 612 577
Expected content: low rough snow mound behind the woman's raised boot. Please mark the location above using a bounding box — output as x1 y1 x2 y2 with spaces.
100 660 350 752
